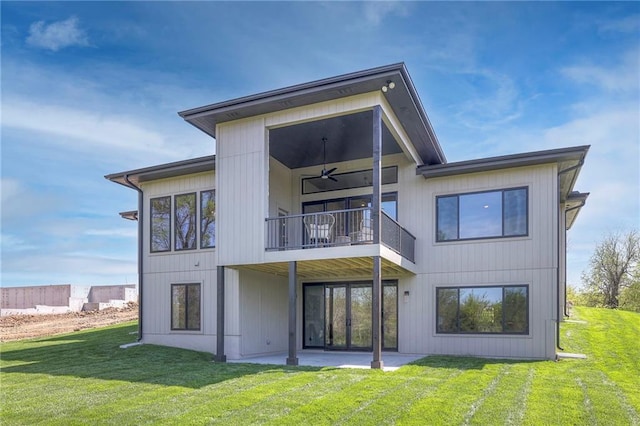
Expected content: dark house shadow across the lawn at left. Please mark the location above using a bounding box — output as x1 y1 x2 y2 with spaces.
0 323 321 389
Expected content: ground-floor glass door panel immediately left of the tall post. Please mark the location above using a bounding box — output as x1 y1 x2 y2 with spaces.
347 285 372 349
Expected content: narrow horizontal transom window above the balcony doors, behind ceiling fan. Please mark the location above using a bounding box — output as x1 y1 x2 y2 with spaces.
302 166 398 194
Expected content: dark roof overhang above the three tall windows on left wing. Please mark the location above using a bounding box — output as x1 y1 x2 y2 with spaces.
105 155 216 188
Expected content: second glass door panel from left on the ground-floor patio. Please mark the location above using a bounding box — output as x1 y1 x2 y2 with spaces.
324 285 347 349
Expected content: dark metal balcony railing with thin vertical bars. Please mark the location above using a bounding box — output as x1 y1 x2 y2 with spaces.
266 207 416 262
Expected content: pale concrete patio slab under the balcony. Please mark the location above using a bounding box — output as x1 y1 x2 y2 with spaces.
227 350 425 371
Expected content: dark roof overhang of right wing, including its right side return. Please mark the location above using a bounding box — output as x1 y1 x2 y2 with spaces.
417 145 589 203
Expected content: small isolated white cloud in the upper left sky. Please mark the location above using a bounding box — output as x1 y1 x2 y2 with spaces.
27 16 89 52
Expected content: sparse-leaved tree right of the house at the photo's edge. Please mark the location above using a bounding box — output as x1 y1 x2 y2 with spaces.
582 230 640 308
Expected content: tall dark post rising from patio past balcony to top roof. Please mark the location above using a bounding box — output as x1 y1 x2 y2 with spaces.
371 105 383 369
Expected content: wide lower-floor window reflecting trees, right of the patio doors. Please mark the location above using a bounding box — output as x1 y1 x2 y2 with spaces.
436 285 529 334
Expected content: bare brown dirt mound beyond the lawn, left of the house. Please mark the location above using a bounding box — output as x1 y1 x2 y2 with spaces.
0 302 138 342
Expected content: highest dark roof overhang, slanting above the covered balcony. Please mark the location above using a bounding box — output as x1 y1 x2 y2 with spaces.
178 63 446 164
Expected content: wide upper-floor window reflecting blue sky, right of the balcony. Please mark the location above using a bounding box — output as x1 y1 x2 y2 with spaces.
436 188 528 241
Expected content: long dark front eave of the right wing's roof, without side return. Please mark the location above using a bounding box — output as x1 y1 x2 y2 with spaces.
416 145 590 179
